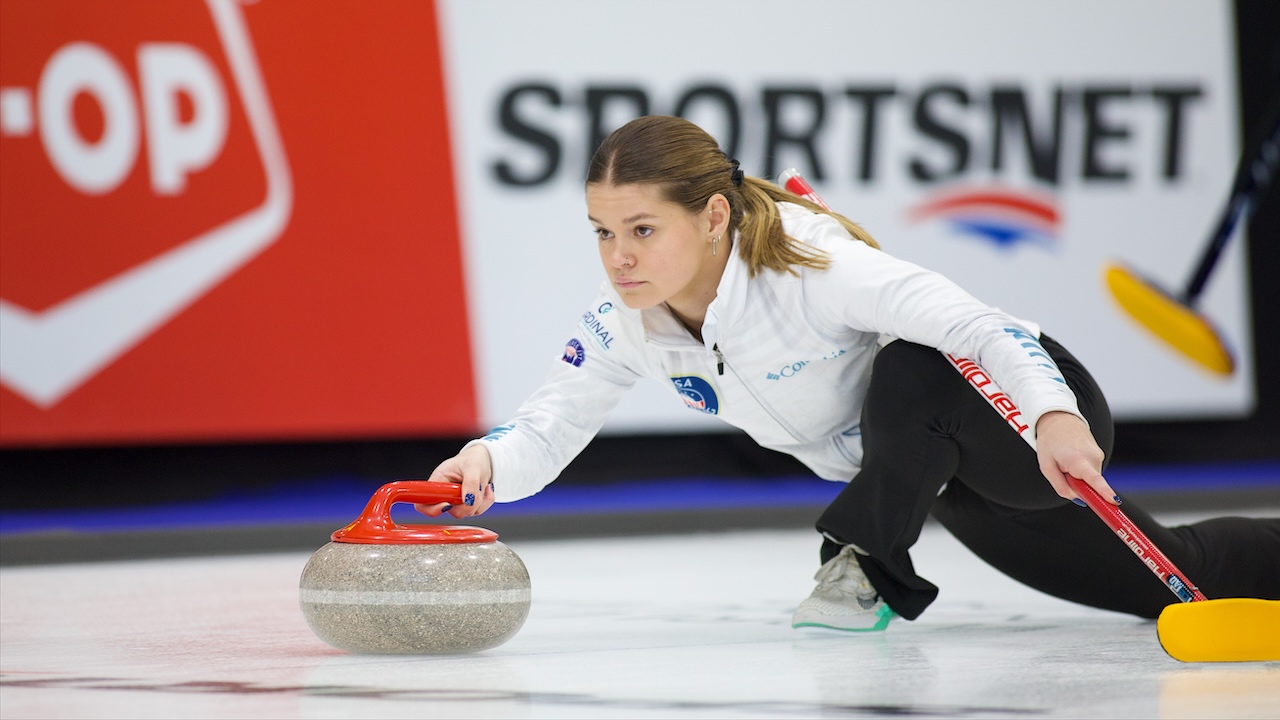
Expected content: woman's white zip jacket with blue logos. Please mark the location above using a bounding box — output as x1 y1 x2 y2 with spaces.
467 202 1083 502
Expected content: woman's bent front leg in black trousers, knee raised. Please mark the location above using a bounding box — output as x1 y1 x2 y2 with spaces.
817 337 1112 619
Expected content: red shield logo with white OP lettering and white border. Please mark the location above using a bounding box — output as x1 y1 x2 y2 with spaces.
0 0 293 407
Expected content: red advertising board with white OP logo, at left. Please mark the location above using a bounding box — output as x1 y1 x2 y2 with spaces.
0 0 477 447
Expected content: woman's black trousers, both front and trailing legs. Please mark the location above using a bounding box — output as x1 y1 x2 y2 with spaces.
818 337 1280 620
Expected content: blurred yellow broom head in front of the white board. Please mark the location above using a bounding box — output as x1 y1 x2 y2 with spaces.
1106 265 1235 375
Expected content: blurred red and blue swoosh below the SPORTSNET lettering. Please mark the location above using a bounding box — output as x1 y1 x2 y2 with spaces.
906 186 1062 249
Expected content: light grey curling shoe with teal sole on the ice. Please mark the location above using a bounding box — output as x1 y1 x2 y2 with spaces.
791 544 897 633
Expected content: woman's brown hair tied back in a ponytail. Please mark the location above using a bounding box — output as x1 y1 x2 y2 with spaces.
586 115 879 277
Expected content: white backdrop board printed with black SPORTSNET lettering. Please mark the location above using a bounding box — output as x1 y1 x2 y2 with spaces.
439 0 1254 432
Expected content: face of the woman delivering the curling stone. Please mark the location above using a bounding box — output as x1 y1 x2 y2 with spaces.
586 183 719 310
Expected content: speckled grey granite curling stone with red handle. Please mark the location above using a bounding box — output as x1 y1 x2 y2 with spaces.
300 480 530 655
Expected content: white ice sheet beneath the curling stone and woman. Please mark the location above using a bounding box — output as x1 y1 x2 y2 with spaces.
0 509 1280 719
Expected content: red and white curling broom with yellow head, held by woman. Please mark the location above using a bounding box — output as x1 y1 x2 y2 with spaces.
778 169 1280 662
